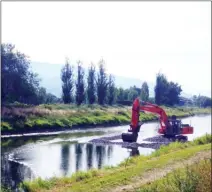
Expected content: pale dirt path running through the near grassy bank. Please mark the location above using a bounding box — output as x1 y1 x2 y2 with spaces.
111 150 211 192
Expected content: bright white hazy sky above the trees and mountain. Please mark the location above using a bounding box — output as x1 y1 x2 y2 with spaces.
2 1 211 95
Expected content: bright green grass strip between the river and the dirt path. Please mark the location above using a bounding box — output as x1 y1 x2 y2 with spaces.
21 135 212 192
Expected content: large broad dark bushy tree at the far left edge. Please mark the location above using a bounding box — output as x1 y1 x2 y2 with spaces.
1 44 40 104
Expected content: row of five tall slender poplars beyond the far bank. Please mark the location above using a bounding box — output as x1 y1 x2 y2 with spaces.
61 59 116 105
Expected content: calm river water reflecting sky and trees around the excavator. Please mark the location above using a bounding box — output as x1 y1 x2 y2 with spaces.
1 115 211 191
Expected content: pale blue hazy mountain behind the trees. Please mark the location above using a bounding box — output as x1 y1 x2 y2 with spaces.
31 62 192 98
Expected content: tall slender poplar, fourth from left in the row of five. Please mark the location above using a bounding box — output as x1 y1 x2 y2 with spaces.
96 59 108 105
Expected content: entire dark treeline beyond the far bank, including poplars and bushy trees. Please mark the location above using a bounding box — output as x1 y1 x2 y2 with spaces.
1 44 211 107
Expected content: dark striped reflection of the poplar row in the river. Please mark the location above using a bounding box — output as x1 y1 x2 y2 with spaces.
60 143 113 176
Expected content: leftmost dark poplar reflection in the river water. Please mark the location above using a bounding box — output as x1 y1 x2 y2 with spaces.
60 144 70 175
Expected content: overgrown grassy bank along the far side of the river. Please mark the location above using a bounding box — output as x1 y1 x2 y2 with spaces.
1 104 211 134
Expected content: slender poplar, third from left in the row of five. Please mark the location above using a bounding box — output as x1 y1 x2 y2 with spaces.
87 64 96 104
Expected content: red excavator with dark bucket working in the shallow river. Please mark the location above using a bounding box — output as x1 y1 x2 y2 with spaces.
122 98 193 142
